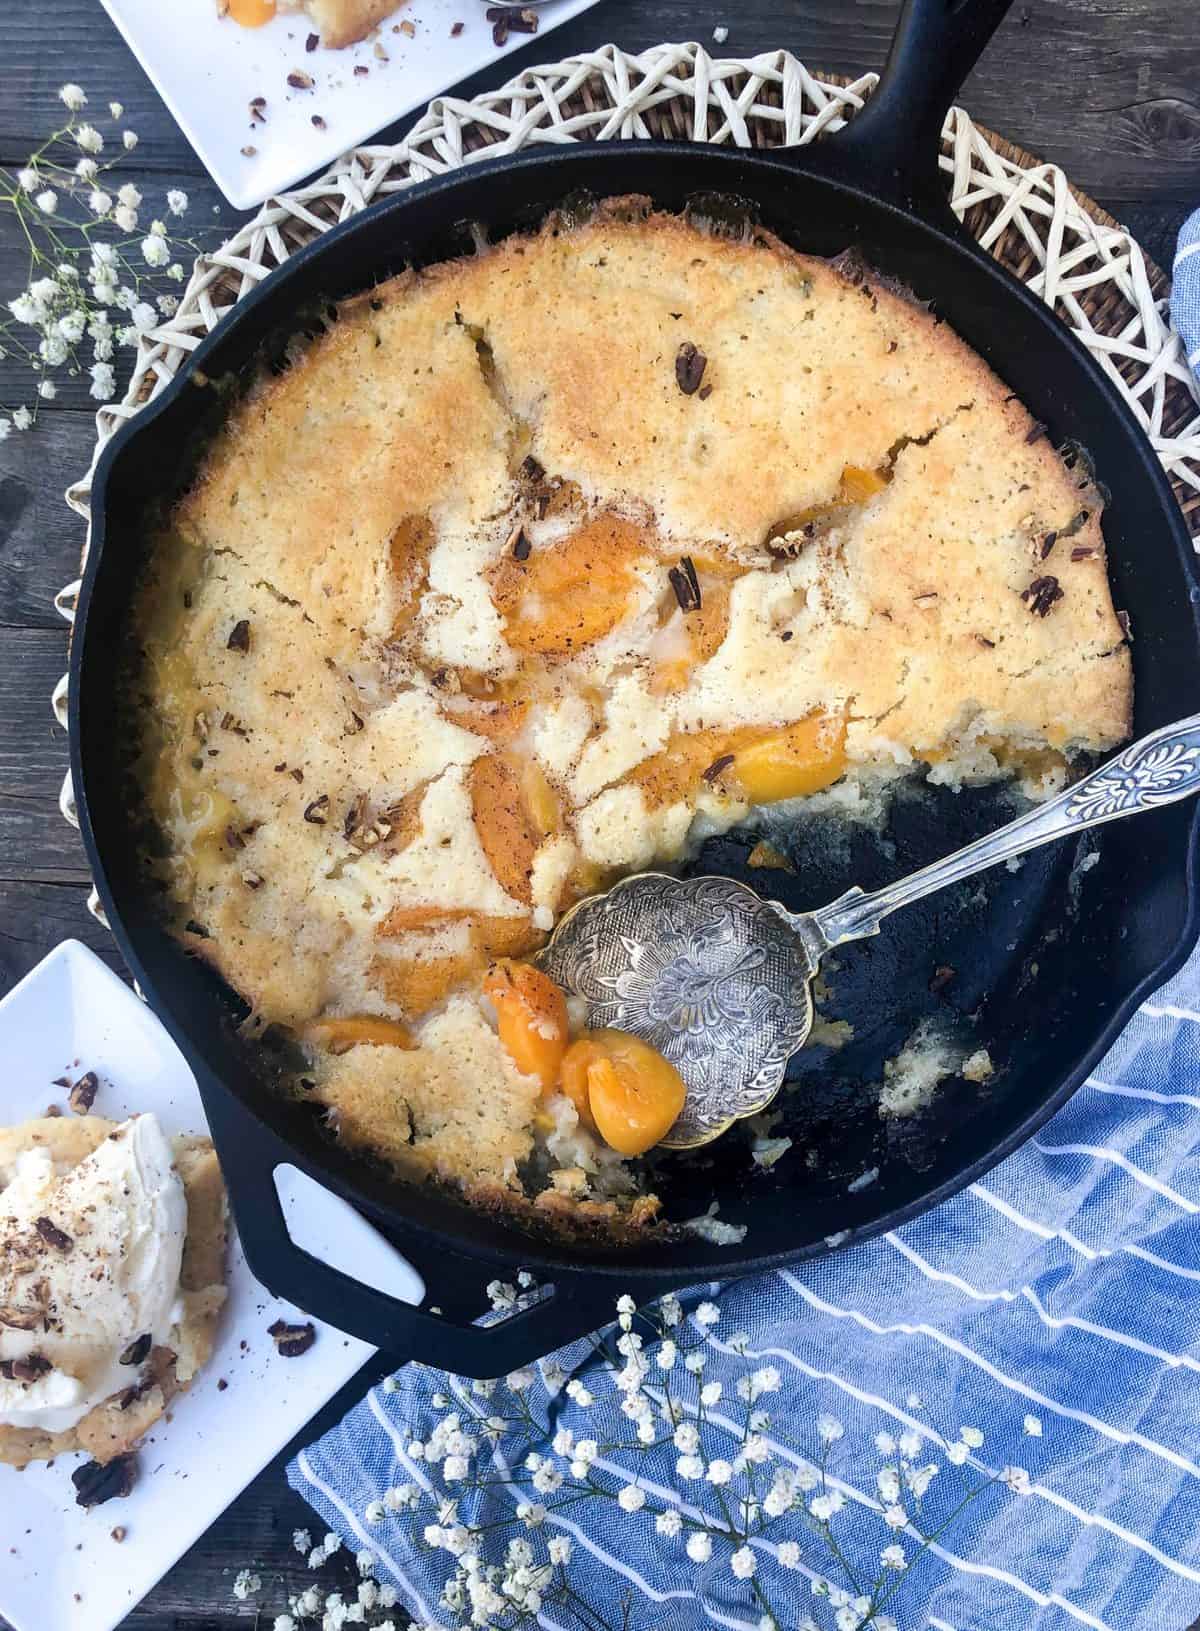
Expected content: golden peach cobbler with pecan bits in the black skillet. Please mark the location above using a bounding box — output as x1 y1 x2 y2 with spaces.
126 202 1130 1230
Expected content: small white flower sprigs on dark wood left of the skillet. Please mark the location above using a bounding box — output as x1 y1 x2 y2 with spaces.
0 83 194 440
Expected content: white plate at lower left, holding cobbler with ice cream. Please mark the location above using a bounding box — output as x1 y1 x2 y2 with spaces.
0 939 424 1631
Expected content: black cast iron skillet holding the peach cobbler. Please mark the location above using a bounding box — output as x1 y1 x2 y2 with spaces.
70 0 1200 1375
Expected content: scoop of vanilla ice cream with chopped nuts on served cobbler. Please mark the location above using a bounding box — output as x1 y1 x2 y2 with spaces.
0 1116 188 1432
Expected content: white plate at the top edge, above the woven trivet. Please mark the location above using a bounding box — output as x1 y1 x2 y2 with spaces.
96 0 595 209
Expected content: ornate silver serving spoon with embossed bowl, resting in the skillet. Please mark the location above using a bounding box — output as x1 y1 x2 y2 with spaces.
538 714 1200 1150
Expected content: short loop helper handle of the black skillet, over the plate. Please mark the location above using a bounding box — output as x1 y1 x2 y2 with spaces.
191 1059 613 1378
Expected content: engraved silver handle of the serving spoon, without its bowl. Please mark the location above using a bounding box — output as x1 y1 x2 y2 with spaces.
802 714 1200 949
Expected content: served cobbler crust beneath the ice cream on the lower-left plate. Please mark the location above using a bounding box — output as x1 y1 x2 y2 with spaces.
0 1116 227 1466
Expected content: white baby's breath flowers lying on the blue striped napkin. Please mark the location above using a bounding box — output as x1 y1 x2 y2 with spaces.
244 1277 1040 1631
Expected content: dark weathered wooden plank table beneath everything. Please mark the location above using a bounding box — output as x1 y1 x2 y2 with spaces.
0 0 1200 1631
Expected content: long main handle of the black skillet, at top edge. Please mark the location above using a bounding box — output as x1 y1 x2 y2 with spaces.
830 0 1013 221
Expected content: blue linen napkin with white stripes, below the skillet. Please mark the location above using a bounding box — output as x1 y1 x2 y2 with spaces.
289 954 1200 1631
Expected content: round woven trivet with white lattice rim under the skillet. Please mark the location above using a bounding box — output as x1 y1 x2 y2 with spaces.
54 44 1200 915
